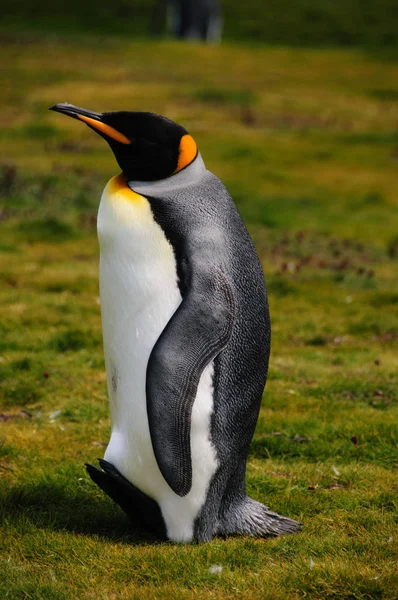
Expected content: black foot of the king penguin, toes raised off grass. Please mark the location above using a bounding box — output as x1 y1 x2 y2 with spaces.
86 459 167 539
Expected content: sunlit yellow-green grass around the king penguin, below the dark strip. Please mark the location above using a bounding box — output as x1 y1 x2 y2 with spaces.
0 31 398 600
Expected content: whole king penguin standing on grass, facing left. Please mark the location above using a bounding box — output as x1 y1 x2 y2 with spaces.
51 104 300 542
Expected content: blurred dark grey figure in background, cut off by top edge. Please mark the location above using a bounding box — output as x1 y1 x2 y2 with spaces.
151 0 222 43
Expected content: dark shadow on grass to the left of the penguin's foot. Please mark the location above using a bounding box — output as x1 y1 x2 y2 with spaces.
0 480 162 546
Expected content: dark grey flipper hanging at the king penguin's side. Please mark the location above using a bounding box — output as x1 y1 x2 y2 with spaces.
146 267 235 496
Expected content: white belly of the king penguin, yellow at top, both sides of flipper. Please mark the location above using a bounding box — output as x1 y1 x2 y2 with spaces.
98 176 218 542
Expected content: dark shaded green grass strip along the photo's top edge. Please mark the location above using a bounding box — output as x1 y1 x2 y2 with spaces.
0 0 398 47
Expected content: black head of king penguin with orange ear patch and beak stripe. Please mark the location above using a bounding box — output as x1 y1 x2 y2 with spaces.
50 103 198 181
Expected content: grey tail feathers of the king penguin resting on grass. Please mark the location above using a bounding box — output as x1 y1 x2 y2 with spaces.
219 498 301 537
